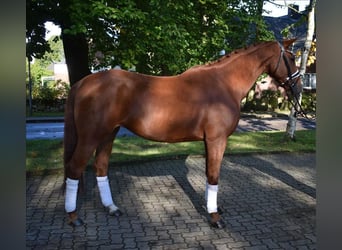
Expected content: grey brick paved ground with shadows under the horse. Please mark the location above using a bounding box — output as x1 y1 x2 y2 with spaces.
26 153 316 249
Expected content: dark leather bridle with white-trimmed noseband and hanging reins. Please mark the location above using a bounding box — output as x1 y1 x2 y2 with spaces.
274 42 309 119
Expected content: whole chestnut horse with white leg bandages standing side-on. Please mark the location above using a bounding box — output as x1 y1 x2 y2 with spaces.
64 39 301 228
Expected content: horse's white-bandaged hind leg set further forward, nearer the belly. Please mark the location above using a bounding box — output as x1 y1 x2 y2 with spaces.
94 127 122 217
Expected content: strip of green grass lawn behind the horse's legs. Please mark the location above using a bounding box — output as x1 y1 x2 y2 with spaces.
26 130 316 173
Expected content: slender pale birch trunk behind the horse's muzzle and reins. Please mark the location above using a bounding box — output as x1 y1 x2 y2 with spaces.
286 0 316 140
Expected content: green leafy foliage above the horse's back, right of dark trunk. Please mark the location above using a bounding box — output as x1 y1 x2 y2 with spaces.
92 0 276 75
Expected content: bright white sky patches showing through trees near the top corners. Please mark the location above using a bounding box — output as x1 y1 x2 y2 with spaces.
45 0 310 40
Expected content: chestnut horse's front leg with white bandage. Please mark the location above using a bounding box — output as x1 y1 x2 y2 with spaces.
205 137 227 228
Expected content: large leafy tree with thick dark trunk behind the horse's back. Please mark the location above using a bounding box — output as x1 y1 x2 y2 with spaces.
26 0 276 84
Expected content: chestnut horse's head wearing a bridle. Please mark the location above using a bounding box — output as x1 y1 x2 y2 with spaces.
270 39 302 97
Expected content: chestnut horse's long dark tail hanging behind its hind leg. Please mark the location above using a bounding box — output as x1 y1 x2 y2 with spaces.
63 84 77 189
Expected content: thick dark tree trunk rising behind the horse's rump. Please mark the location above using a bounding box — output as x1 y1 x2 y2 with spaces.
62 31 91 86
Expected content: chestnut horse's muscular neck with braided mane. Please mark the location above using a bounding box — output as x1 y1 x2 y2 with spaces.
221 43 274 102
